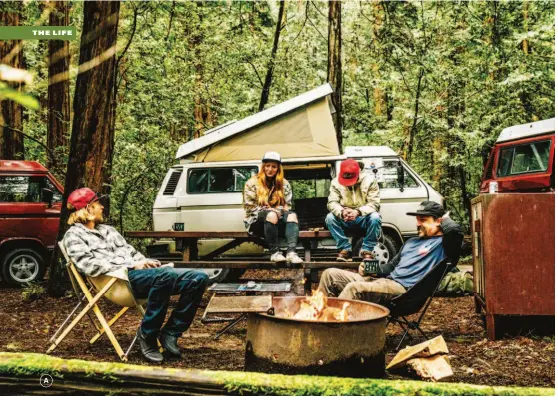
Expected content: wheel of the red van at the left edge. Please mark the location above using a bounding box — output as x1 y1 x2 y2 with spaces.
1 249 46 286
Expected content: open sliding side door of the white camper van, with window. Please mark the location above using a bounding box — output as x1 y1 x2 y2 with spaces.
177 164 258 232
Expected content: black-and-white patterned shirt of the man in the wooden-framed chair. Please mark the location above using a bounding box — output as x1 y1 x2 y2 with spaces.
63 223 146 276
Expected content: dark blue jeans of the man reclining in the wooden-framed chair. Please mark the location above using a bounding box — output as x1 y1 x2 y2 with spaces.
128 267 208 337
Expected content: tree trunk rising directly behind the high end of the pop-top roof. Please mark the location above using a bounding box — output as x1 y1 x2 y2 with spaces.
327 0 343 150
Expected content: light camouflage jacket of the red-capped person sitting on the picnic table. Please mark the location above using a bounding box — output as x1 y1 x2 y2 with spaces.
327 173 380 218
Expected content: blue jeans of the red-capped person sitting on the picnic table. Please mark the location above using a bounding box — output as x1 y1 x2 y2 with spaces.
326 212 382 252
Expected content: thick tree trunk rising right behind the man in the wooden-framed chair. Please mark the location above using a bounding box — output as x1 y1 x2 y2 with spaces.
47 1 120 296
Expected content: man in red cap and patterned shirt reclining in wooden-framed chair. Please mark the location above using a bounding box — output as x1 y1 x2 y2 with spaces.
63 188 208 363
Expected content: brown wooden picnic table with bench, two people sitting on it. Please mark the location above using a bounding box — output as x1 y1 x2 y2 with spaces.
124 230 364 293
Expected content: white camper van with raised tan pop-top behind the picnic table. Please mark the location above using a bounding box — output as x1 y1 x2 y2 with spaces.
153 84 443 280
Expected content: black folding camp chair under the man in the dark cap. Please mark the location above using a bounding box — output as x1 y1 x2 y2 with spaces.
386 258 452 350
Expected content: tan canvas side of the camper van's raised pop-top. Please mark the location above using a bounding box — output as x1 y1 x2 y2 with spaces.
194 98 339 162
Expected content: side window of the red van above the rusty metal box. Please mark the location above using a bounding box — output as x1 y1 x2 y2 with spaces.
498 140 550 177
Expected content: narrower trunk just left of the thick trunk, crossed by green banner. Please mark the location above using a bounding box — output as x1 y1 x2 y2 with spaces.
47 1 70 176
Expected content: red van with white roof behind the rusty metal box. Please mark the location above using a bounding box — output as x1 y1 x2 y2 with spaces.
480 118 554 193
